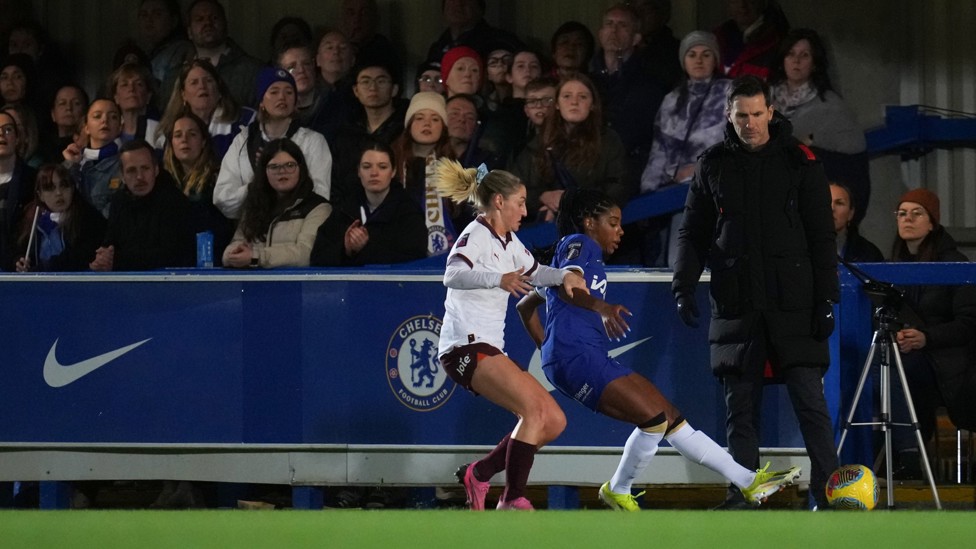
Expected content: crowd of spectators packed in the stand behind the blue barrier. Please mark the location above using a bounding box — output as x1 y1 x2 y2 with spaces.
0 0 868 272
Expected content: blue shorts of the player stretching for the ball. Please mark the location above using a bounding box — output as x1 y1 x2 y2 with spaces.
542 351 632 411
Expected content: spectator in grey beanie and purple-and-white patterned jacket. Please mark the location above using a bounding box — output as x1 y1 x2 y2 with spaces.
640 31 731 267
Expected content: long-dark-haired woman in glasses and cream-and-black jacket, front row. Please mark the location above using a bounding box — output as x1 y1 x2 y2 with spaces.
223 139 332 269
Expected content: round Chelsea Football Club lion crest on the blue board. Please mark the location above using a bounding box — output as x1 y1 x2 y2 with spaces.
386 315 457 412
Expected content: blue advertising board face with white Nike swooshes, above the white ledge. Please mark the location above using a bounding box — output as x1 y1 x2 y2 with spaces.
0 271 802 447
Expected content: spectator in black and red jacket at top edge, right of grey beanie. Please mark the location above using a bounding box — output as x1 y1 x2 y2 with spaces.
712 0 790 80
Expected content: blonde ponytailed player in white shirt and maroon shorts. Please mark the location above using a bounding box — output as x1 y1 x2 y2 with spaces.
434 159 587 510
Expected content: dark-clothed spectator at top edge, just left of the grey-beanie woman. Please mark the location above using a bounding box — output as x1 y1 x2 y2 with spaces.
630 0 684 88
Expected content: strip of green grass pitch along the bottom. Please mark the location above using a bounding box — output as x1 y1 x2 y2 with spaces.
0 509 976 549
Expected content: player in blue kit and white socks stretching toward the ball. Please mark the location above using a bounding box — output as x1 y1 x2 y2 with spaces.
518 189 800 511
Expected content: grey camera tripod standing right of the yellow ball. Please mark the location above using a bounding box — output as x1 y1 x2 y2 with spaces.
837 305 942 510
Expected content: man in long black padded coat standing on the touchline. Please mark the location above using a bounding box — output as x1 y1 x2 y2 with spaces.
672 76 839 508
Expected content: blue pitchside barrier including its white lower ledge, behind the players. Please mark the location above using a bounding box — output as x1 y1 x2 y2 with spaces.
0 264 974 506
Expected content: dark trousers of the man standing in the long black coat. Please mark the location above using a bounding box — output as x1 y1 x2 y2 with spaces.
722 338 838 507
